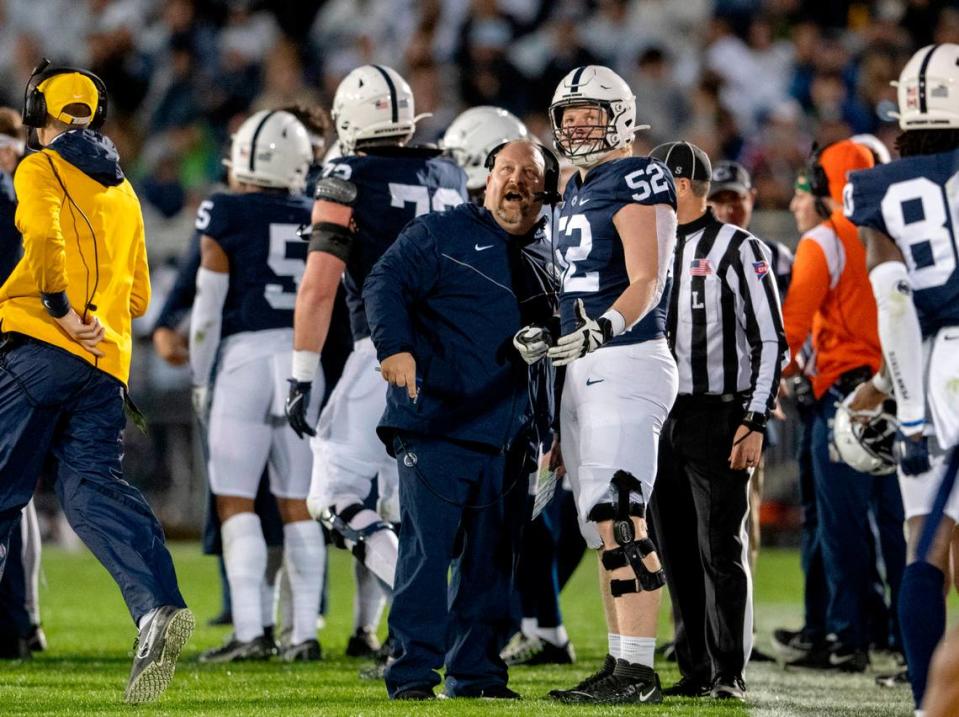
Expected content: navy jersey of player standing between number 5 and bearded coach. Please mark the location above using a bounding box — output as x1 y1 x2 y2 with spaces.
323 147 468 341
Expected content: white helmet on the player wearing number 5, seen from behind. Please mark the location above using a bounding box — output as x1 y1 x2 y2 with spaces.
230 110 313 192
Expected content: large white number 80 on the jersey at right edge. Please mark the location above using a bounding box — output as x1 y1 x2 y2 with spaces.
880 173 959 290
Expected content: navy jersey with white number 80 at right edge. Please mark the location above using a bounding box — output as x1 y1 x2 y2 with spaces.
843 150 959 336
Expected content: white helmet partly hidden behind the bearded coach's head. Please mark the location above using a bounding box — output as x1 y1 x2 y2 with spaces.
440 105 529 191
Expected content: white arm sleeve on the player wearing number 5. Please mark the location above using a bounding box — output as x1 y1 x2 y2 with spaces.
190 236 230 386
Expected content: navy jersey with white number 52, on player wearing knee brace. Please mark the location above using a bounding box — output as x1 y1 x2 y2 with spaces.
556 157 676 346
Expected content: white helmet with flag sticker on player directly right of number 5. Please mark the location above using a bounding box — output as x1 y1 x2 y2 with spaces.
331 65 425 154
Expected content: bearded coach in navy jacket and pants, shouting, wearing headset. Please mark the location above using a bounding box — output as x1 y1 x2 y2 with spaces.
363 140 559 699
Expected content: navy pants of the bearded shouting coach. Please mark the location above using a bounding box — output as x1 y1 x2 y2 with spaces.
386 434 529 697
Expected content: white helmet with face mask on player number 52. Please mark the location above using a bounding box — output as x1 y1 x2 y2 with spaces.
549 65 641 167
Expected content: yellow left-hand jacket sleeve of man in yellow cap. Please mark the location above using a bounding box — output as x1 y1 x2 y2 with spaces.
13 153 70 316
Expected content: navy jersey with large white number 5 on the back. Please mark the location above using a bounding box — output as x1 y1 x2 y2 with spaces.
196 192 312 338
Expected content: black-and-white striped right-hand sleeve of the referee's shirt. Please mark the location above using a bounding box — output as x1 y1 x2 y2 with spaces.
736 238 789 415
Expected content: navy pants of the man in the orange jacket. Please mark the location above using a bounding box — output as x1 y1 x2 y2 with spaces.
812 390 906 649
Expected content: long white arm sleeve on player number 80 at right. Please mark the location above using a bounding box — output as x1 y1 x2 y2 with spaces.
869 261 926 434
